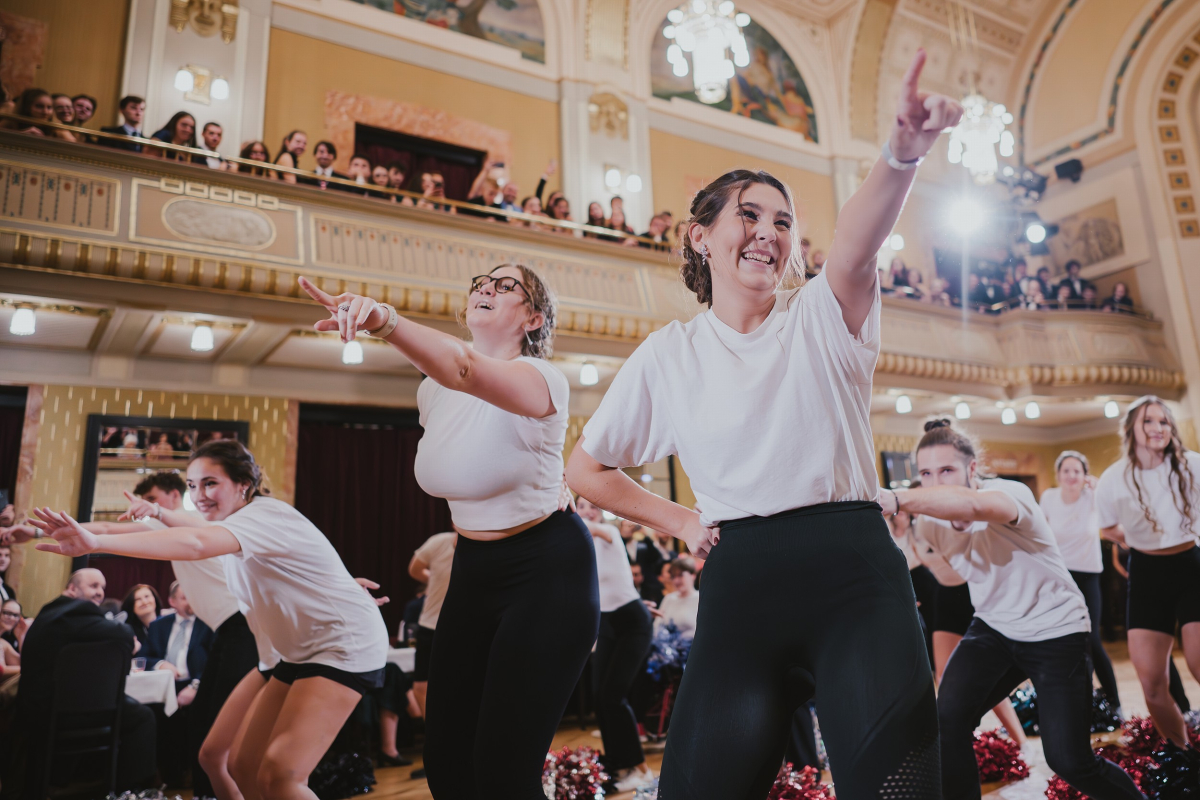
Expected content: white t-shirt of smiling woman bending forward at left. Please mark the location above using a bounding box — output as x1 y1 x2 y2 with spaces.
216 498 388 673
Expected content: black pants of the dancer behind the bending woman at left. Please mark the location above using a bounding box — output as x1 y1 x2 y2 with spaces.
188 612 258 798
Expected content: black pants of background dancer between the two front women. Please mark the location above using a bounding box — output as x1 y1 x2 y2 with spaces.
592 600 653 770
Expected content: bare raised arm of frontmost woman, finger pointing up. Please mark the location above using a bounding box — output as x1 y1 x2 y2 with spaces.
824 49 962 336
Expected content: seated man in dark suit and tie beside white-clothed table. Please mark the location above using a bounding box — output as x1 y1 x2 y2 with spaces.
146 581 216 786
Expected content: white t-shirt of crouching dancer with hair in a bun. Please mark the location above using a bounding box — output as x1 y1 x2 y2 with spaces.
918 479 1092 642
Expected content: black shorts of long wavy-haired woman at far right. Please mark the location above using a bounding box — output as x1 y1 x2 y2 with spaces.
1126 547 1200 636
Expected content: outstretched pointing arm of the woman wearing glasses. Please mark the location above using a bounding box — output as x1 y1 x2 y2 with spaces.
300 278 557 419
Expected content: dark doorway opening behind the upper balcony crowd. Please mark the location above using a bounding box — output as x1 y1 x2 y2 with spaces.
354 124 487 200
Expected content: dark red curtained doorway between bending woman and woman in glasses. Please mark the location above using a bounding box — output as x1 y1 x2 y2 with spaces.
295 403 452 636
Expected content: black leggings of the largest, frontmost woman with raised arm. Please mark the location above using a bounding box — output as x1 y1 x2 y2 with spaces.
659 501 942 800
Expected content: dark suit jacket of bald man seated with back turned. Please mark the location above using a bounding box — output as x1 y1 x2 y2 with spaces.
17 595 133 726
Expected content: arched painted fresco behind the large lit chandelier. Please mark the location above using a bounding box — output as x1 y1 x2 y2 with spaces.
650 19 817 142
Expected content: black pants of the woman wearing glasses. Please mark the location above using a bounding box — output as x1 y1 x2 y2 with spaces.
425 511 600 800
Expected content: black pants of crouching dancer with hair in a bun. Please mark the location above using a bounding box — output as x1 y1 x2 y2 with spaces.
937 618 1145 800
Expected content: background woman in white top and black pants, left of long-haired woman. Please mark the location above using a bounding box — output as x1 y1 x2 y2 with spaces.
1040 450 1123 718
